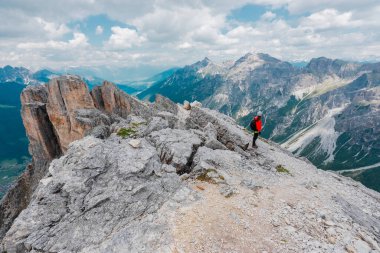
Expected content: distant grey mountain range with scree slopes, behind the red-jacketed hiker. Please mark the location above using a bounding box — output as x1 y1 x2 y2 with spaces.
138 53 380 191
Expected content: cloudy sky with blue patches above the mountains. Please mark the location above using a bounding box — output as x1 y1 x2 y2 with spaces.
0 0 380 78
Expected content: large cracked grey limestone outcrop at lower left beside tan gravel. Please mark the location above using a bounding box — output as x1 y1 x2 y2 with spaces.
3 137 180 252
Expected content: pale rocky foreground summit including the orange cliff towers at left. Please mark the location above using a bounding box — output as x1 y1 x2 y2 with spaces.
0 76 380 253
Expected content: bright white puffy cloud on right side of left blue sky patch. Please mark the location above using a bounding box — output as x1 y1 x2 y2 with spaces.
107 26 146 49
